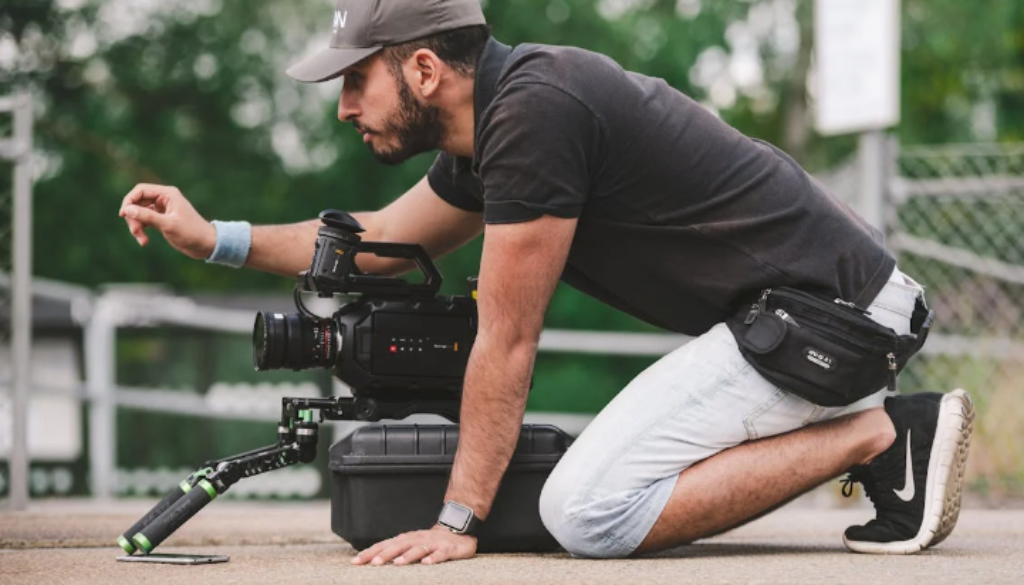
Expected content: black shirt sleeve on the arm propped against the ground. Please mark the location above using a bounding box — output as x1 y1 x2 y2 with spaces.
478 82 601 223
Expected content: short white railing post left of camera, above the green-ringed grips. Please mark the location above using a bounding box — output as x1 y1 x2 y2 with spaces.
85 293 117 500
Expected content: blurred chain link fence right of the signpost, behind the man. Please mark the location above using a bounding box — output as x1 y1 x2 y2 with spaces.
887 144 1024 497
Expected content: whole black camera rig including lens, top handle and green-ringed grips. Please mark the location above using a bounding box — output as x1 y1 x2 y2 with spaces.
117 210 476 554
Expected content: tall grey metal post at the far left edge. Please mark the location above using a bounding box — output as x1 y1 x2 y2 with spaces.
9 93 32 510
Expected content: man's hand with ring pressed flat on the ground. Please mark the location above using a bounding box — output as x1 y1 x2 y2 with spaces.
352 526 476 565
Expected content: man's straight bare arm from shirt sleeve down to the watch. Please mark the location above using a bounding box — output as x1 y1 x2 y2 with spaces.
446 216 577 516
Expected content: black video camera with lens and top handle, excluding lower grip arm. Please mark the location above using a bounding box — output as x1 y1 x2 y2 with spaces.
253 210 477 402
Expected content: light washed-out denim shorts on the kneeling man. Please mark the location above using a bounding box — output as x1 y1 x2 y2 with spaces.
540 268 923 558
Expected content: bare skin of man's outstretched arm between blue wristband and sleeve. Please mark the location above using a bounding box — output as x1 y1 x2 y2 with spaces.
246 177 483 277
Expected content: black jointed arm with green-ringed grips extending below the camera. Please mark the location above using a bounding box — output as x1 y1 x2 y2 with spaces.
117 396 459 554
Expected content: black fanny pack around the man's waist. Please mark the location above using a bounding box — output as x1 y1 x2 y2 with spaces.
726 287 935 407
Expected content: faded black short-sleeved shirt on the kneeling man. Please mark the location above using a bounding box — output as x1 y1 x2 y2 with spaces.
428 40 895 335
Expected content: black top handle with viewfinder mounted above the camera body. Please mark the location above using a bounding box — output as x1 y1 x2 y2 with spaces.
299 209 441 297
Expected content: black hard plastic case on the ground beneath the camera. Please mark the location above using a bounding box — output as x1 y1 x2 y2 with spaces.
330 425 572 552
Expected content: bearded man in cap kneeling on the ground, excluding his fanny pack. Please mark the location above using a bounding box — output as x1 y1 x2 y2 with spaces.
121 0 973 565
